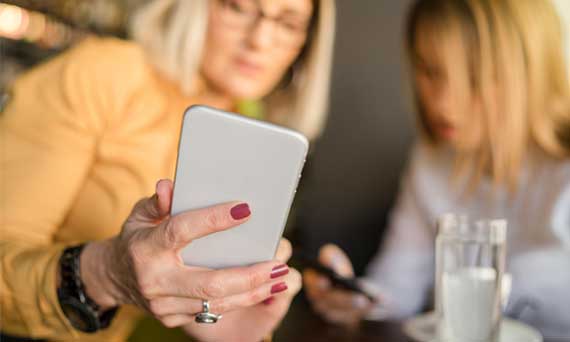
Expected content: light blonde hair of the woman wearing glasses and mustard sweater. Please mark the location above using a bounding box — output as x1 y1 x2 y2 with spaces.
130 0 335 139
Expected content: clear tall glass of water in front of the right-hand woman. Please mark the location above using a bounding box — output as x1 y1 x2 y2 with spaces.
435 215 507 342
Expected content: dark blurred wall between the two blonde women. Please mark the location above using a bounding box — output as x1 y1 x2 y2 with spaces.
297 0 414 271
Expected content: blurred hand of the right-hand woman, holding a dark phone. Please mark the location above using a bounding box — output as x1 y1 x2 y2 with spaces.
303 245 373 326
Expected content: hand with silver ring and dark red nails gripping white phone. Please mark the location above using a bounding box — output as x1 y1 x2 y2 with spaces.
81 180 289 327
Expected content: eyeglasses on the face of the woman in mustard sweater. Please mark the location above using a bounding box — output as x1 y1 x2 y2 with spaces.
217 0 310 46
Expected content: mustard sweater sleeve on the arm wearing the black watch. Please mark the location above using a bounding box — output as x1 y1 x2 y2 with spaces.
0 36 144 339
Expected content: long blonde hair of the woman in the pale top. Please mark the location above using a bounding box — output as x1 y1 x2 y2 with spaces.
407 0 570 190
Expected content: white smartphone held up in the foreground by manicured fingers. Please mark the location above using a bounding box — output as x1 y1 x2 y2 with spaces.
171 106 309 269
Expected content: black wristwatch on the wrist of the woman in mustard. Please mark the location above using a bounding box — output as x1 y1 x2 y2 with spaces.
57 244 117 333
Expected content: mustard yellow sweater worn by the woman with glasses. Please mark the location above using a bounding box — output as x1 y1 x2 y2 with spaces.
0 38 192 341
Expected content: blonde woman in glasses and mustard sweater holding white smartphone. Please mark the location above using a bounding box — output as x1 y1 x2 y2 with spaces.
0 0 334 341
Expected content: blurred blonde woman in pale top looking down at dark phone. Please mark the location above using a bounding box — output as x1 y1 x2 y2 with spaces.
305 0 570 338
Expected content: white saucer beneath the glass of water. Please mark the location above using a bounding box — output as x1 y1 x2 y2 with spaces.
404 312 542 342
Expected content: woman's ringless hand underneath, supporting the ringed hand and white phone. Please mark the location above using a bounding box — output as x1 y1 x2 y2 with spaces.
184 239 302 342
